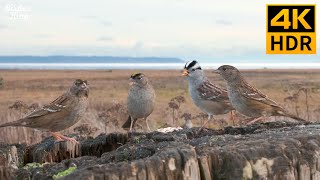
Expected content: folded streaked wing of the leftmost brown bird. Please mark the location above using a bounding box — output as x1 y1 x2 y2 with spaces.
24 94 69 119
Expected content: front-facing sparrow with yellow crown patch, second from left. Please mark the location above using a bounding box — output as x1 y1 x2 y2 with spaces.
122 73 156 131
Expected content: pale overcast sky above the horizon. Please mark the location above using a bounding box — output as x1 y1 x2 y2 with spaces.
0 0 320 61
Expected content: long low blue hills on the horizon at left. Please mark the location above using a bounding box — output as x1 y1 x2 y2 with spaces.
0 56 184 63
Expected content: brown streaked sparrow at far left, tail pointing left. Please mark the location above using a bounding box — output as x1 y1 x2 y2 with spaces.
0 79 89 143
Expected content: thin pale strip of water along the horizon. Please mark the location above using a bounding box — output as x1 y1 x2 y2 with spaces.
0 63 320 70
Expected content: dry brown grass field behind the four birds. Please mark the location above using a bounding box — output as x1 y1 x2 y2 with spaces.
0 69 320 144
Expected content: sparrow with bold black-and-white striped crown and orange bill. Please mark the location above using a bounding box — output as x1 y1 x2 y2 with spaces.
182 60 234 126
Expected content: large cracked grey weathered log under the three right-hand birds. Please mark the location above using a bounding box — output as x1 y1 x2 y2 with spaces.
10 123 320 179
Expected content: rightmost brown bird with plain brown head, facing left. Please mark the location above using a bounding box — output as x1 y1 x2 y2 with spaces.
215 65 306 122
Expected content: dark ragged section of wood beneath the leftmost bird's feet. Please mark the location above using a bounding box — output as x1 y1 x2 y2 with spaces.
24 134 128 164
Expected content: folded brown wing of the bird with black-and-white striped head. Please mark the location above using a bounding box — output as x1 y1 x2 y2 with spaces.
198 80 229 102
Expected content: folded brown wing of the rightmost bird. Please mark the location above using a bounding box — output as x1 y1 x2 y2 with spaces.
239 82 281 108
